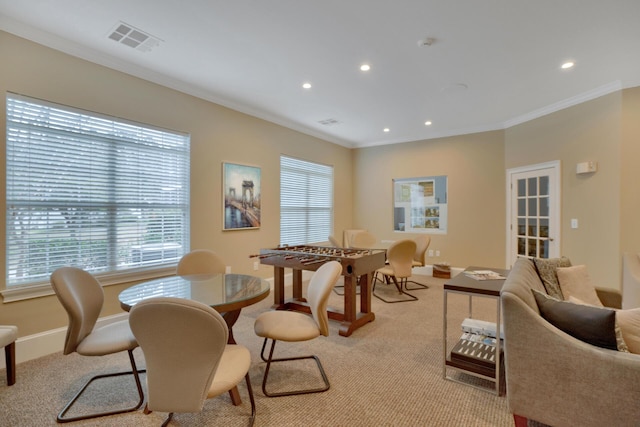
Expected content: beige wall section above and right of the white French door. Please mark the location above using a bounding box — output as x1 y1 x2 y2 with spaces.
505 92 621 288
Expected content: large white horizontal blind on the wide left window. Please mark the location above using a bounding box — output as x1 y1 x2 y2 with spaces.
6 94 190 287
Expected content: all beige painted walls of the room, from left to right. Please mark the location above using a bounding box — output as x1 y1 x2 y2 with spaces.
0 28 640 336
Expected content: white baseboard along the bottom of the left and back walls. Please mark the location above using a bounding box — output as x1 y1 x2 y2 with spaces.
0 265 464 369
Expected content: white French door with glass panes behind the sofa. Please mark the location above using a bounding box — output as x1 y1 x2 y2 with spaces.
507 161 560 268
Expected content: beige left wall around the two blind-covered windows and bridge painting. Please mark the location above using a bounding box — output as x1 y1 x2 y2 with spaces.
0 32 352 336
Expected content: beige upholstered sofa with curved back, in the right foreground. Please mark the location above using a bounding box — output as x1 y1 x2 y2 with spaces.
501 259 640 427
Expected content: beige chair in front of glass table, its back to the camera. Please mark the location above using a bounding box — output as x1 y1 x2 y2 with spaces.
129 297 256 426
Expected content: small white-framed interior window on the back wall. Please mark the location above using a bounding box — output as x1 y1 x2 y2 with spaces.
393 176 447 234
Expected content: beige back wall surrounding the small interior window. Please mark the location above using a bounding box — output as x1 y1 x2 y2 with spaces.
353 131 506 268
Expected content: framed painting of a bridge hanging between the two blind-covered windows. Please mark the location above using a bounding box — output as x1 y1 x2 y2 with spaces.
222 162 261 231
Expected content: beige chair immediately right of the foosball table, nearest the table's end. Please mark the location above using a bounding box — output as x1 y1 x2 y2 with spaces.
373 239 418 303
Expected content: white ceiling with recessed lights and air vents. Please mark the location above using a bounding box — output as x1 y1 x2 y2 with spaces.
0 0 640 147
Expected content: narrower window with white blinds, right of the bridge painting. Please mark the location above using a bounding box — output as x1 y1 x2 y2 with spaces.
280 156 333 245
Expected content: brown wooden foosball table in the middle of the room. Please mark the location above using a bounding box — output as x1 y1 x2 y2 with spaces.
253 245 386 337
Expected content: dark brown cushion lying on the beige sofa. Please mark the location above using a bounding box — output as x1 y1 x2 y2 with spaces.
532 289 618 350
